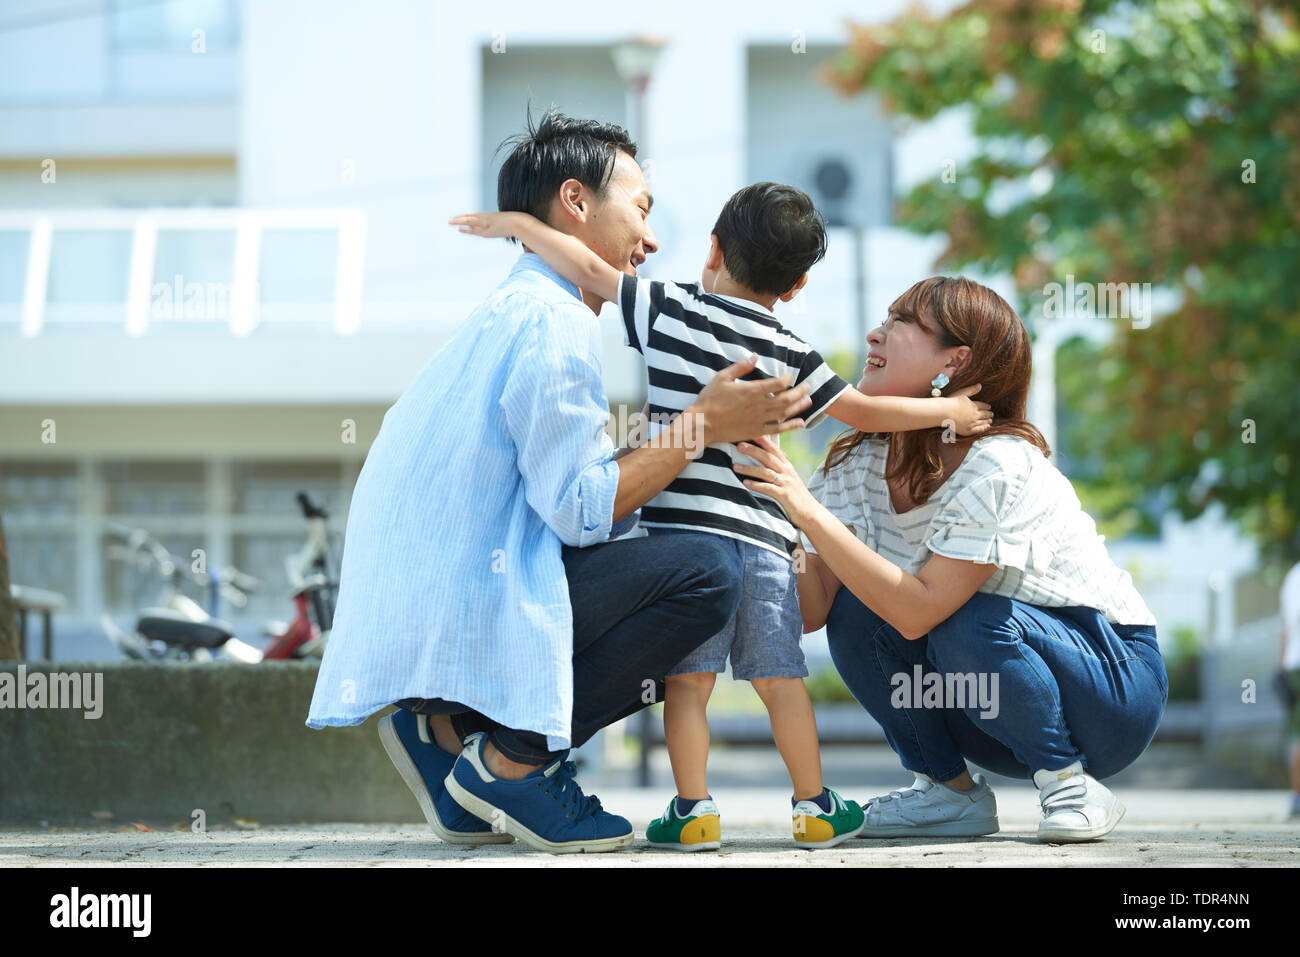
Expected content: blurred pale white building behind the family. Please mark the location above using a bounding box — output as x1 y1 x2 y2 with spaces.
0 0 1268 658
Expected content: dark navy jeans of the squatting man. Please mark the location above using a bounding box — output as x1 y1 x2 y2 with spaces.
397 533 742 765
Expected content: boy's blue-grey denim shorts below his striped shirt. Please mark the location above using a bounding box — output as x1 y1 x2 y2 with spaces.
645 527 809 681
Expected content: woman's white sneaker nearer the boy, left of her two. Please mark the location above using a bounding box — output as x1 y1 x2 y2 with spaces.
858 771 998 837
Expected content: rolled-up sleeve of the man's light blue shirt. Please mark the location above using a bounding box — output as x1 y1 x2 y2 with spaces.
501 307 627 547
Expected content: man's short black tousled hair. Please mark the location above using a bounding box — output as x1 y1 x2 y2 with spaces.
497 107 637 235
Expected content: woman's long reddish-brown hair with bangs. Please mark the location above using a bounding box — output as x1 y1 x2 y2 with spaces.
822 276 1052 505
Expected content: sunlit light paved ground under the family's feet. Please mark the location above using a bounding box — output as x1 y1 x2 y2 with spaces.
0 784 1300 867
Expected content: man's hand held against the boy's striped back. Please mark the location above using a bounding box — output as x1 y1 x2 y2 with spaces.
681 355 813 445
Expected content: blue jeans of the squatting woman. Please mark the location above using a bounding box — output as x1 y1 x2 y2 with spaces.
827 588 1169 781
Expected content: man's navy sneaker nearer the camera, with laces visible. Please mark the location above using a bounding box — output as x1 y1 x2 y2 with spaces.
447 732 636 854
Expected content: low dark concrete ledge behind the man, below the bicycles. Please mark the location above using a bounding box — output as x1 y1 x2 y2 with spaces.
0 662 411 824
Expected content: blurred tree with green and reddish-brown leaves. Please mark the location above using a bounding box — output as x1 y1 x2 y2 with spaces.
826 0 1300 558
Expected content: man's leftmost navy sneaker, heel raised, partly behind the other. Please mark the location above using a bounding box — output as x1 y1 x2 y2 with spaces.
380 709 515 844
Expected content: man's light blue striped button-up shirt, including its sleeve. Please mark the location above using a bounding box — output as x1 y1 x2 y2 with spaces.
307 252 636 750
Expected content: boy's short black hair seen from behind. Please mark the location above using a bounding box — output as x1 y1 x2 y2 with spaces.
714 183 826 295
